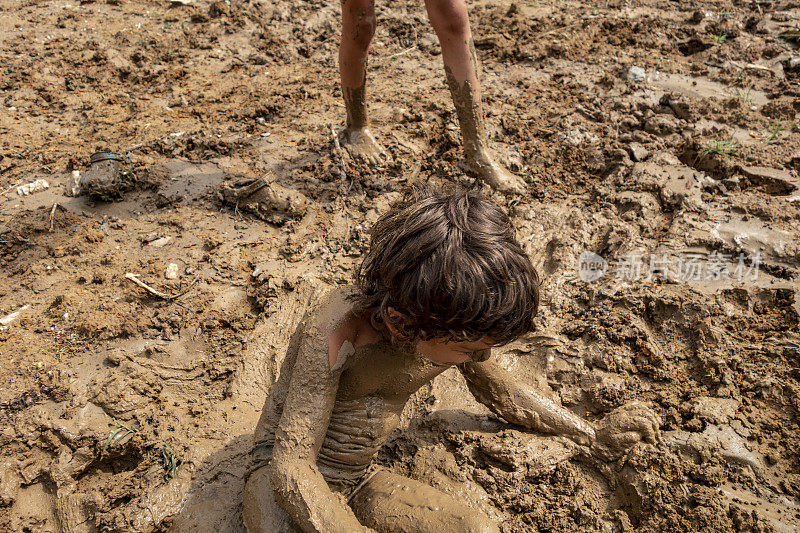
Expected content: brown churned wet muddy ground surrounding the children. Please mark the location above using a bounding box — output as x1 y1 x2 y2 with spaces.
0 0 800 532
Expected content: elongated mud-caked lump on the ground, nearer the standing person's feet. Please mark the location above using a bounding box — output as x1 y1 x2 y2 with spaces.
220 178 311 224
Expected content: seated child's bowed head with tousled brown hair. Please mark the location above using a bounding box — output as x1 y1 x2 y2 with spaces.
356 190 539 362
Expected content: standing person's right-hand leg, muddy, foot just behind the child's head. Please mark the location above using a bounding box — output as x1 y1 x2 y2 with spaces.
425 0 525 193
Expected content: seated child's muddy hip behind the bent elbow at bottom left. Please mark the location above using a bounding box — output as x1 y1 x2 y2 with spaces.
242 466 300 533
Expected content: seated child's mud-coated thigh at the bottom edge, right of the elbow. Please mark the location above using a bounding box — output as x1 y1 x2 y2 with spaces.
350 470 500 533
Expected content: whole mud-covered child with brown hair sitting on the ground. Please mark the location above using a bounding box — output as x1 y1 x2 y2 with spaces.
243 187 659 533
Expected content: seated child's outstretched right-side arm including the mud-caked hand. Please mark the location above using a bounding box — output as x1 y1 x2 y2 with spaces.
459 357 661 458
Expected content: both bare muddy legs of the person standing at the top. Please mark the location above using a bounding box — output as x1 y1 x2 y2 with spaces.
339 0 525 193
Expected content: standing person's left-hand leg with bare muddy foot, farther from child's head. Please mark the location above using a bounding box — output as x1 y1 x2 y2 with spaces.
339 0 386 164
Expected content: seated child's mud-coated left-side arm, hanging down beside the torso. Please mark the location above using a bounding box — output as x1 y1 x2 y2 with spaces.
270 321 373 533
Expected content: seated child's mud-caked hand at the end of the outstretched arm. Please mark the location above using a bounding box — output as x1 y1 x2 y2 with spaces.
592 402 663 461
